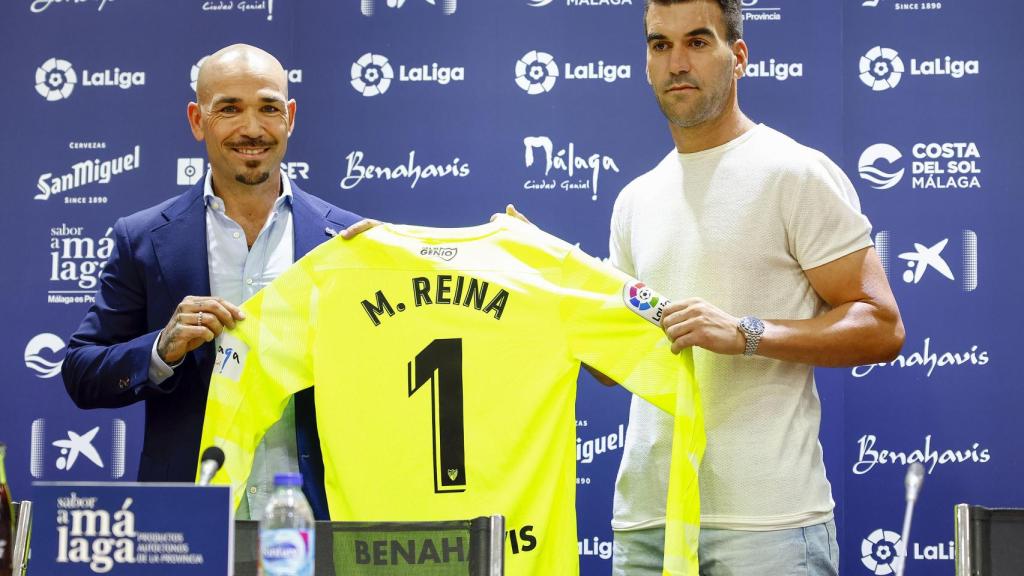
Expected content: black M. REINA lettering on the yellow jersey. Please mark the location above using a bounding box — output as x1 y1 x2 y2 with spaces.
362 274 509 326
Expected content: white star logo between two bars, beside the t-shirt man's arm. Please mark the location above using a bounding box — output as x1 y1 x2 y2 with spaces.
874 229 978 292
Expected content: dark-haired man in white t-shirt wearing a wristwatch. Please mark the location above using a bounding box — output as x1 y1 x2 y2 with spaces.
610 0 904 576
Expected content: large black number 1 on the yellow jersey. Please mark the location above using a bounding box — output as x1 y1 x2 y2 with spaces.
408 338 466 493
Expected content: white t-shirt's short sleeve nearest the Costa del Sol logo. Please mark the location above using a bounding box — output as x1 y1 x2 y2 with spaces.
786 151 871 270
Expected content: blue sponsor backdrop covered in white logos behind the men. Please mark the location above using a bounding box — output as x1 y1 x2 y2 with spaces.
0 0 1024 575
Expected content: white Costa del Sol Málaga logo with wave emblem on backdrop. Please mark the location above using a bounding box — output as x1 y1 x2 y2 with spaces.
857 141 982 190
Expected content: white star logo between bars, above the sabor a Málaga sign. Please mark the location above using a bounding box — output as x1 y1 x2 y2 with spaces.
30 418 126 479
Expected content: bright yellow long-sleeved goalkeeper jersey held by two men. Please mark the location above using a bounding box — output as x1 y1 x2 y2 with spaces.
202 216 705 576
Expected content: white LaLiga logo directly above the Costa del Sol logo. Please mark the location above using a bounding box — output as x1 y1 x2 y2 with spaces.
857 45 981 92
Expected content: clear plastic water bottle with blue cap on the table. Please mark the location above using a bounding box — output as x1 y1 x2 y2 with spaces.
259 474 315 576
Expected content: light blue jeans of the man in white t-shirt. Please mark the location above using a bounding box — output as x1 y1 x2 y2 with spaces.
611 521 839 576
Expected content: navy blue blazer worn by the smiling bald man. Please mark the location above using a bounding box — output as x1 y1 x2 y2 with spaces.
61 182 359 520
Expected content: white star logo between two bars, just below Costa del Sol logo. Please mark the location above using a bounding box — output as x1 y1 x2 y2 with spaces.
874 230 978 292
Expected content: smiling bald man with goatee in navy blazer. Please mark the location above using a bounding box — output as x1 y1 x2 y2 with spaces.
61 44 358 519
